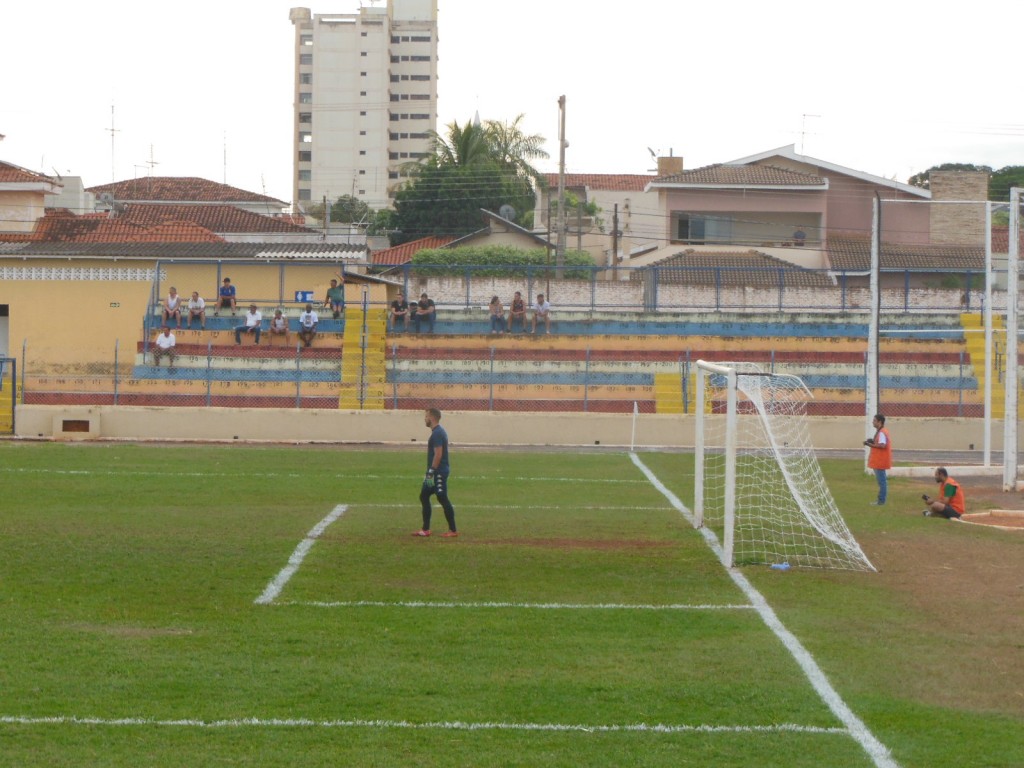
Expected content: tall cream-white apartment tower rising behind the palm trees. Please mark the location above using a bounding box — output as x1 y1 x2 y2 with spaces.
290 0 437 215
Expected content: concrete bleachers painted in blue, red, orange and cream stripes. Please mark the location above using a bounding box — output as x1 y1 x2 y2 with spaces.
26 306 1007 416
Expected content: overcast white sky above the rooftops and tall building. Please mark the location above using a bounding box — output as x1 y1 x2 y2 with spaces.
0 0 1024 201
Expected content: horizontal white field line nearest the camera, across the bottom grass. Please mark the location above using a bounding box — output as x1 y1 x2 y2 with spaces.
0 716 847 735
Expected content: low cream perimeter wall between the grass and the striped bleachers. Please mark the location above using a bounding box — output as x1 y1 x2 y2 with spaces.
15 406 1002 451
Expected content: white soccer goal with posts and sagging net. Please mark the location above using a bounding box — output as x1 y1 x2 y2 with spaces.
693 360 874 570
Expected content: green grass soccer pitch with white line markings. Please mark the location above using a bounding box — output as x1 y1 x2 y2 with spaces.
0 442 1024 767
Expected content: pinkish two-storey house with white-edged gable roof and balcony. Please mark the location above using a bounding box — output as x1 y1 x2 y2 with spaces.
643 145 987 278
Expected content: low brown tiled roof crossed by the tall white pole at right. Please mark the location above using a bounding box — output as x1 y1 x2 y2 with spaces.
827 237 985 272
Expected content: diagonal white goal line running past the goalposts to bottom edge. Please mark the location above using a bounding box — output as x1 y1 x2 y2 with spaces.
630 453 899 768
